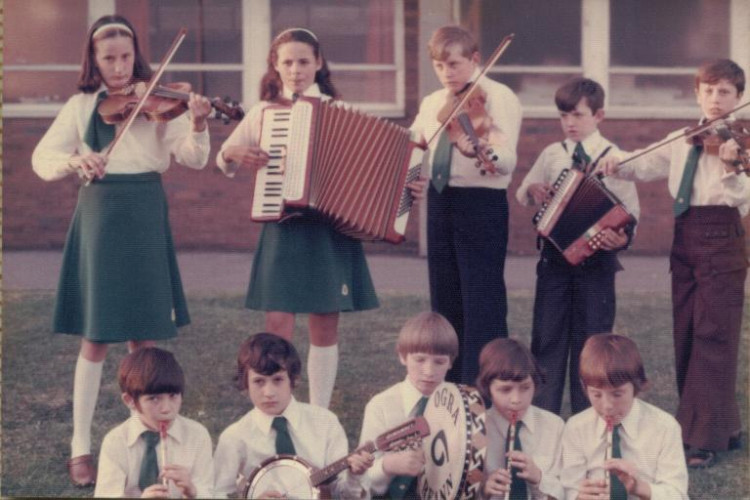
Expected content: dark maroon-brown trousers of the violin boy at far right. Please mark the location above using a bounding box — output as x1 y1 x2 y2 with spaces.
670 206 748 451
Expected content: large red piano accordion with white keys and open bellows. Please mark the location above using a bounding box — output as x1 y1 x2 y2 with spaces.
251 97 424 243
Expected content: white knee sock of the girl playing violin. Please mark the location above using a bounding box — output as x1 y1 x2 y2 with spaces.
70 355 104 458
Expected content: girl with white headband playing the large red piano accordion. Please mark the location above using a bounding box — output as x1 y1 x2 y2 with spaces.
216 28 378 408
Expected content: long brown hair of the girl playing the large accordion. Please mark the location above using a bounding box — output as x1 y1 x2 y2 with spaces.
260 29 339 101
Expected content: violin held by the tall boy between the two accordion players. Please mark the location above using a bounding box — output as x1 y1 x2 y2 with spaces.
437 83 498 175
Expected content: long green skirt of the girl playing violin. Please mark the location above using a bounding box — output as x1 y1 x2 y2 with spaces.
54 172 190 342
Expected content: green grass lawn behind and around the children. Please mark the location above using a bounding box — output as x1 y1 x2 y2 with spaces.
0 291 750 500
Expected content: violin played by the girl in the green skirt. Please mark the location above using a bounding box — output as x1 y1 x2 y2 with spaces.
98 82 245 125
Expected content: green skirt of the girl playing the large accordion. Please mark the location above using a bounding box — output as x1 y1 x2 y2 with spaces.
245 214 379 314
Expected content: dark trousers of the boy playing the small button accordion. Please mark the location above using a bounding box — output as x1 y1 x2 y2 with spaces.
531 243 621 414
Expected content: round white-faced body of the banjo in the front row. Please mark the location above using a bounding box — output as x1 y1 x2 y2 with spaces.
241 455 327 499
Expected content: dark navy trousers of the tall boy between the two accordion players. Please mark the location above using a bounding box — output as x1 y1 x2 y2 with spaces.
427 186 508 385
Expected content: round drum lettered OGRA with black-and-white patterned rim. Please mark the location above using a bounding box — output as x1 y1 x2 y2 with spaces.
417 382 487 500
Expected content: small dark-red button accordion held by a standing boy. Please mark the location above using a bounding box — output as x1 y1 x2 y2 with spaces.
534 169 635 266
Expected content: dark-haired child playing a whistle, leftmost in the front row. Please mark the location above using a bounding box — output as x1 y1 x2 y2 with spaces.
94 347 214 498
